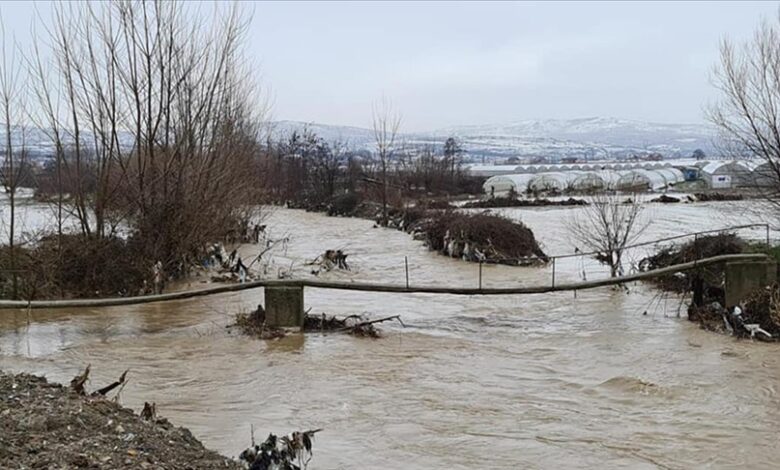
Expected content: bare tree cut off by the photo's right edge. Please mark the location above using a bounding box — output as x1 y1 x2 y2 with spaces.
707 15 780 205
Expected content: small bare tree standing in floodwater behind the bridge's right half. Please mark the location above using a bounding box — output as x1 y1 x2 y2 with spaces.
568 194 647 277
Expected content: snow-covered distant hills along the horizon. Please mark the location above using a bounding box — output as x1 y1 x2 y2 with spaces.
273 117 716 160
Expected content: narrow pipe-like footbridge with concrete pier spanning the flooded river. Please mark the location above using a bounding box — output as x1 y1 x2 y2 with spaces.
0 254 777 327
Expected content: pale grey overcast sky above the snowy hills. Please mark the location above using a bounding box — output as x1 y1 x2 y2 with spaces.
2 2 778 131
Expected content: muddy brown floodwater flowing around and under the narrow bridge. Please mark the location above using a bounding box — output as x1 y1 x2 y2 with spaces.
0 202 780 469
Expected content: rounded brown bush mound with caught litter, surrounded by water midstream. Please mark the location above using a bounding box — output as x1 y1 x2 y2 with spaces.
421 212 549 266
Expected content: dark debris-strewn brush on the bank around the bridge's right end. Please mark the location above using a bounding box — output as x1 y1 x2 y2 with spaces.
640 233 780 341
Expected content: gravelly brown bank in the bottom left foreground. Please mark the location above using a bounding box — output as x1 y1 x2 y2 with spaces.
0 371 245 470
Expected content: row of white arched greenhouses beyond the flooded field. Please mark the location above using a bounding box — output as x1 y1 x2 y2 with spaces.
483 168 685 196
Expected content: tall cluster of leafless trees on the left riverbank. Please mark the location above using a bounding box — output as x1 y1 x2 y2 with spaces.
25 0 267 274
